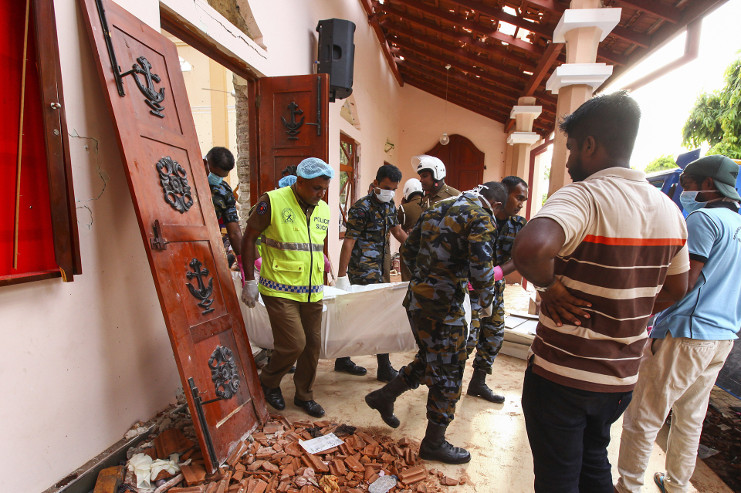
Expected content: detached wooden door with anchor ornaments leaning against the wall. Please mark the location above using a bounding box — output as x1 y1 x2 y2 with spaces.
80 0 268 471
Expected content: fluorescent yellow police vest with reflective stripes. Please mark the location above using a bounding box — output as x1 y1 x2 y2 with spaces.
259 187 329 302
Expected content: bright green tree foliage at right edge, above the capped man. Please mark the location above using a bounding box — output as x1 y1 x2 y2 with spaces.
682 58 741 159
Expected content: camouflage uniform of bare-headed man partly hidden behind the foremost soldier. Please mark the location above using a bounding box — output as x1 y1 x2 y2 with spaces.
466 216 527 374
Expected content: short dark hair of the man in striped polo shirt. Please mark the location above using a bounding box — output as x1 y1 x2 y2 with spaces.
558 91 641 158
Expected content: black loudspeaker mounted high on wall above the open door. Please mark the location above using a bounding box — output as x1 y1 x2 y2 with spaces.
316 19 355 101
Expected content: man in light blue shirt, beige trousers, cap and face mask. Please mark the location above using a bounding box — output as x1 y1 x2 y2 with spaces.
615 155 741 493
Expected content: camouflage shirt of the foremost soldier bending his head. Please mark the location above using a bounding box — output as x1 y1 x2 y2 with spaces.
402 193 496 325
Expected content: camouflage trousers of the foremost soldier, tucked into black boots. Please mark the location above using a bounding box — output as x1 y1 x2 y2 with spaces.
399 310 466 425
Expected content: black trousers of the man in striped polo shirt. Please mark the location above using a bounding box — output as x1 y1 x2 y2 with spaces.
522 366 633 493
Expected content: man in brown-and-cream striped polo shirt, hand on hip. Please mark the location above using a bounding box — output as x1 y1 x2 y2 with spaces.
512 92 689 493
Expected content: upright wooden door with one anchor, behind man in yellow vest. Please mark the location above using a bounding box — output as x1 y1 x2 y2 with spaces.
250 74 329 200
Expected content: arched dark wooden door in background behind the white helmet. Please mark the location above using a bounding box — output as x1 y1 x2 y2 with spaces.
425 134 484 191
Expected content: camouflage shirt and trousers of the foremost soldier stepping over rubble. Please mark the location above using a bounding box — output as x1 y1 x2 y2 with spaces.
400 193 496 425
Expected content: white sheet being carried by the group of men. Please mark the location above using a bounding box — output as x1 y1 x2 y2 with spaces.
233 273 428 359
